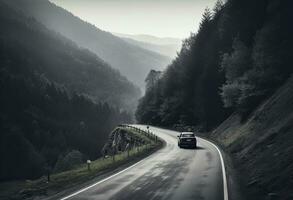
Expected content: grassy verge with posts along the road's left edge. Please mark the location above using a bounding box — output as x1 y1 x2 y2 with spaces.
0 126 163 200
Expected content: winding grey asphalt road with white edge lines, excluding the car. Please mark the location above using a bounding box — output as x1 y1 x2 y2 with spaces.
62 125 228 200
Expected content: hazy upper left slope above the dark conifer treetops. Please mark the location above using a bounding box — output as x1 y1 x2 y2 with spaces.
0 1 140 110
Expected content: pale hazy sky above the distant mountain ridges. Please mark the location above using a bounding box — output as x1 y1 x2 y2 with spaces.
51 0 216 38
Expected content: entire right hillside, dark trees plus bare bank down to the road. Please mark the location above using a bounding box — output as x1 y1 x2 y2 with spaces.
136 0 293 200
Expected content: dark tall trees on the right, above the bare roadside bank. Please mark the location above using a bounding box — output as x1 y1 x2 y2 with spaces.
136 0 293 130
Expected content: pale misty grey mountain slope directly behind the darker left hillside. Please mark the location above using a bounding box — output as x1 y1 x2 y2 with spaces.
3 0 170 88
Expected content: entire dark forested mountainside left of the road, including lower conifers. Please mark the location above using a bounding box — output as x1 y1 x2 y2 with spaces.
0 1 132 180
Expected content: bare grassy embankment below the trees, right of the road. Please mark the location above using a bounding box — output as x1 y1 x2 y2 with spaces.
211 77 293 200
